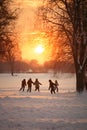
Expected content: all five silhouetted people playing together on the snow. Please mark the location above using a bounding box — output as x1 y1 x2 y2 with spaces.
19 78 59 94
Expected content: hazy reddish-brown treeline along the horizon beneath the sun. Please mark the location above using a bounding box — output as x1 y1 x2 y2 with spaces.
0 60 75 73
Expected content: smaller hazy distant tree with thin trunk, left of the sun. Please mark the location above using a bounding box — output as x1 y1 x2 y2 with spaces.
4 35 21 76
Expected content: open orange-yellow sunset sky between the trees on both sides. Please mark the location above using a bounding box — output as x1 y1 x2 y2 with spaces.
16 0 50 64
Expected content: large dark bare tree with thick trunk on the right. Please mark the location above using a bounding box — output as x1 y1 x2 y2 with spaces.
40 0 87 92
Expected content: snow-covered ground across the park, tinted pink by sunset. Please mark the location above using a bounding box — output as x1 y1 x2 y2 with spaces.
0 73 87 130
